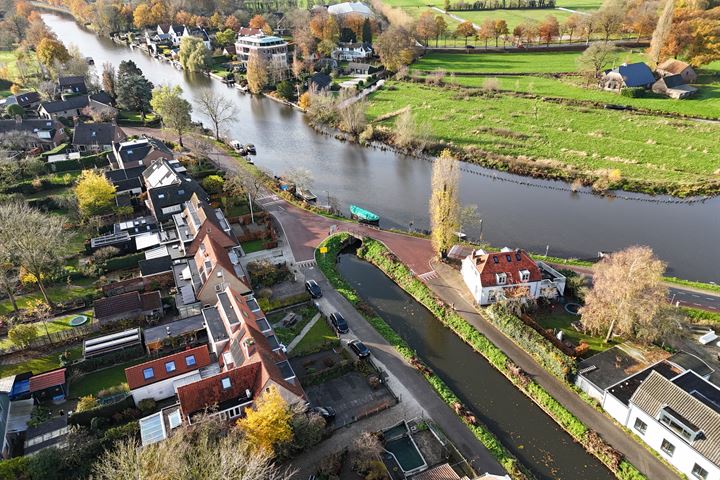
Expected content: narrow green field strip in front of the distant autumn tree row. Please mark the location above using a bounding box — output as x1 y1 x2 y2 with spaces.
412 52 645 73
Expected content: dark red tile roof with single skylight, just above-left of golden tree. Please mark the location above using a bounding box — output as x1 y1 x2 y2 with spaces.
178 363 262 416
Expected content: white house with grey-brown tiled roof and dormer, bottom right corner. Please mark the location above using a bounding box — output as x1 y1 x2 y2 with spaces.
626 370 720 480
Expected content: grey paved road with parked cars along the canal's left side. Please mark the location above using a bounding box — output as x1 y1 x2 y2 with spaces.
303 268 505 475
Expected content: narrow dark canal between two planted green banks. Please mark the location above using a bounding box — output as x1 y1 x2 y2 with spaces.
338 253 614 480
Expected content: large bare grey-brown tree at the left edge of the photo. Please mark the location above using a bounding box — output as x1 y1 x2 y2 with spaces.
0 202 70 305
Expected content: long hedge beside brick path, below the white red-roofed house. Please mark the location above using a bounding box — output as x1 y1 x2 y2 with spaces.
485 303 576 381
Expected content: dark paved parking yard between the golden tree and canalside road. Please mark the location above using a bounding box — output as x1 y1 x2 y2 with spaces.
305 371 397 428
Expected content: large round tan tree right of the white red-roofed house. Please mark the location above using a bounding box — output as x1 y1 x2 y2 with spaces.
580 246 670 341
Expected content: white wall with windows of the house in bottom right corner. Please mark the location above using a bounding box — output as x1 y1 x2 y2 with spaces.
626 402 720 480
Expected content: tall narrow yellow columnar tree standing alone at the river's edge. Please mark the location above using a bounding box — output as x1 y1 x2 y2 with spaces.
430 150 460 257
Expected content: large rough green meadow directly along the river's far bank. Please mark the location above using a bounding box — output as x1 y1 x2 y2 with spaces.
368 81 720 195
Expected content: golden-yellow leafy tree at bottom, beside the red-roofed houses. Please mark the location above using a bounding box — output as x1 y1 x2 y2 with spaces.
237 386 293 453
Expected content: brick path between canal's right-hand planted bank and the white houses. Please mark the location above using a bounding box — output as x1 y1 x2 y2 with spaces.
427 262 678 479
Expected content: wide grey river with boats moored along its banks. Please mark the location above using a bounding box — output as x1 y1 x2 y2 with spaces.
42 14 720 283
